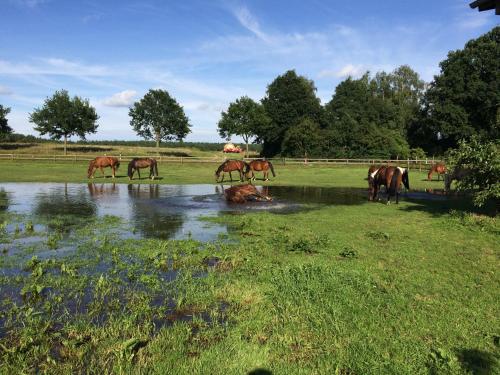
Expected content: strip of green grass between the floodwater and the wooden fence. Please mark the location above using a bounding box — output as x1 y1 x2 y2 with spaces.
0 160 450 190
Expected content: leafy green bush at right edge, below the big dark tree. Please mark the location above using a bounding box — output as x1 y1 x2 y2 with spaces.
449 137 500 207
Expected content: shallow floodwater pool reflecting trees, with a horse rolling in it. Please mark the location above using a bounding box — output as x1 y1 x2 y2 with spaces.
0 183 458 241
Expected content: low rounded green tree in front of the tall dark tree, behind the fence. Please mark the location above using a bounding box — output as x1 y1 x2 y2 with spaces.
282 118 322 159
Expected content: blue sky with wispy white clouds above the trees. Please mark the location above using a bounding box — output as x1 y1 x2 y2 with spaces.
0 0 499 141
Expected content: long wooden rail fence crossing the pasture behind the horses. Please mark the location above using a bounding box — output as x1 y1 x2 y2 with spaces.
0 153 441 169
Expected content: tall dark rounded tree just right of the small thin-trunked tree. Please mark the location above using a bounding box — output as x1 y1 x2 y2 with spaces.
258 70 322 156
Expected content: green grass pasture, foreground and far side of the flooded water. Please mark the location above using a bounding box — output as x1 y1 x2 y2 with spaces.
0 162 500 374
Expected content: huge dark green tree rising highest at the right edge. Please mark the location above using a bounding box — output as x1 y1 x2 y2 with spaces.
410 26 500 151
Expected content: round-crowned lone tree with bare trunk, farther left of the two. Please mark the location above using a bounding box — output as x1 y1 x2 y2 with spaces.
29 90 99 155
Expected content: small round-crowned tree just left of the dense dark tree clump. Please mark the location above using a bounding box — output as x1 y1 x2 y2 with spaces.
218 96 270 157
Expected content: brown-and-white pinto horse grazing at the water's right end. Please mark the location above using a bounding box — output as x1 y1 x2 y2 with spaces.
368 167 410 204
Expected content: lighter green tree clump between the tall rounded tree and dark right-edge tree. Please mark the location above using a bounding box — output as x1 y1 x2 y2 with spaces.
324 66 423 158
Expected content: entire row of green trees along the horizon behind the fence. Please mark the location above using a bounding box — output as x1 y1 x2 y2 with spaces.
0 27 500 158
